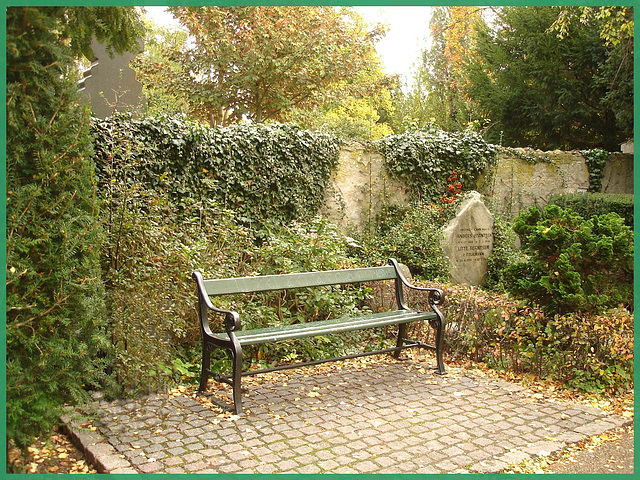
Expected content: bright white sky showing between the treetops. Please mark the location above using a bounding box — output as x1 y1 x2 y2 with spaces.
145 7 431 83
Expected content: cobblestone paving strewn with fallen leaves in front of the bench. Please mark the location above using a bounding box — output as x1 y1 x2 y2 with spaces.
63 362 628 474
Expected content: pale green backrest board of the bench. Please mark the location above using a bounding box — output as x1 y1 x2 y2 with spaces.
204 265 397 296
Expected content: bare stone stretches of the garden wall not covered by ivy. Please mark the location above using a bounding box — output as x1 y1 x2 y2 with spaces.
324 143 633 231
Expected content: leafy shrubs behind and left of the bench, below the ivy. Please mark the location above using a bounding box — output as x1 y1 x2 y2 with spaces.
103 194 376 395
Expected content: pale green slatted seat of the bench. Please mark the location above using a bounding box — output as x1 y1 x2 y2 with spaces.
215 310 436 345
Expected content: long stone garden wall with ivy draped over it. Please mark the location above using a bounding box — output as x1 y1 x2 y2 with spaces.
93 114 633 231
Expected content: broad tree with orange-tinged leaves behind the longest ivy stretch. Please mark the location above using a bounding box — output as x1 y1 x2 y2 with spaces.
135 6 383 125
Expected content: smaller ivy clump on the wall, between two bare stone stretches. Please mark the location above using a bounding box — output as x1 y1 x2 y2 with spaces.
373 125 497 202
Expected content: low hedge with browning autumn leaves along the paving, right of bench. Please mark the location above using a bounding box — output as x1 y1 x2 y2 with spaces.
409 282 634 394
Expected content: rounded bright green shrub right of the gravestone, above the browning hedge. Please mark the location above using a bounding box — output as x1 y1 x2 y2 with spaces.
505 205 633 314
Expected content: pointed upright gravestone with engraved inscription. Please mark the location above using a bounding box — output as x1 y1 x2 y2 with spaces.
444 192 493 285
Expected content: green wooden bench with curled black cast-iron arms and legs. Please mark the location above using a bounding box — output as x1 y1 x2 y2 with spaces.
193 259 445 415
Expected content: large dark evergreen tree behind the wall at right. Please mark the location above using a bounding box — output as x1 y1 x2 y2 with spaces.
466 7 632 151
